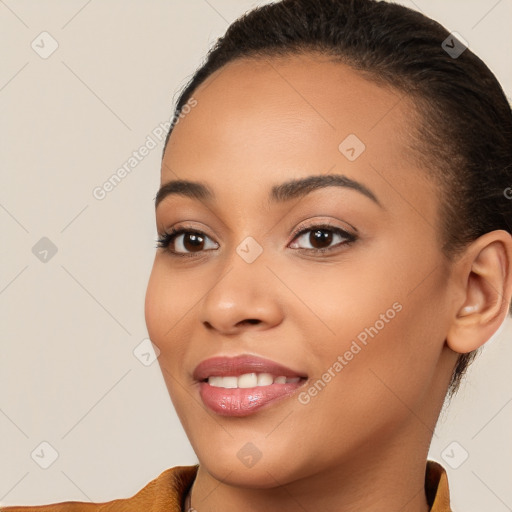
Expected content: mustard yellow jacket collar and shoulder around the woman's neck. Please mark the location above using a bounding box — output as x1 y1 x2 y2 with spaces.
0 460 452 512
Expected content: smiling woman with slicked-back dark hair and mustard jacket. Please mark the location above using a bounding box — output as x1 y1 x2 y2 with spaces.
3 0 512 512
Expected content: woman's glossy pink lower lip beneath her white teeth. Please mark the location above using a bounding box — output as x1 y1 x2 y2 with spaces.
199 380 305 416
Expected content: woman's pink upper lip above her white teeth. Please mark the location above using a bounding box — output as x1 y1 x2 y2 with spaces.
193 355 307 381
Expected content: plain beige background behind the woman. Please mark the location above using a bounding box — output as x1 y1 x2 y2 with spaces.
0 0 512 512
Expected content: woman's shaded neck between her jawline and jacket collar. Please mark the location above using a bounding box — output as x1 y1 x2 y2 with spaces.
190 428 430 512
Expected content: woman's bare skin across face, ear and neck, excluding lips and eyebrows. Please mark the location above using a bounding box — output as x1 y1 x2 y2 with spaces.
145 55 512 512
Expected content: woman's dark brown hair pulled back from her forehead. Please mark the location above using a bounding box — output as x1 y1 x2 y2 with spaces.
164 0 512 396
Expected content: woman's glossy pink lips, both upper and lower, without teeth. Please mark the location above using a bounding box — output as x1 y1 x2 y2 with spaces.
193 355 307 417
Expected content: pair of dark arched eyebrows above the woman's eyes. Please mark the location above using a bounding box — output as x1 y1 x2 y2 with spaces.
155 174 383 208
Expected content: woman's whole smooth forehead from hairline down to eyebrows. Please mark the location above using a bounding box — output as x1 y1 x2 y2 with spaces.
162 54 434 218
